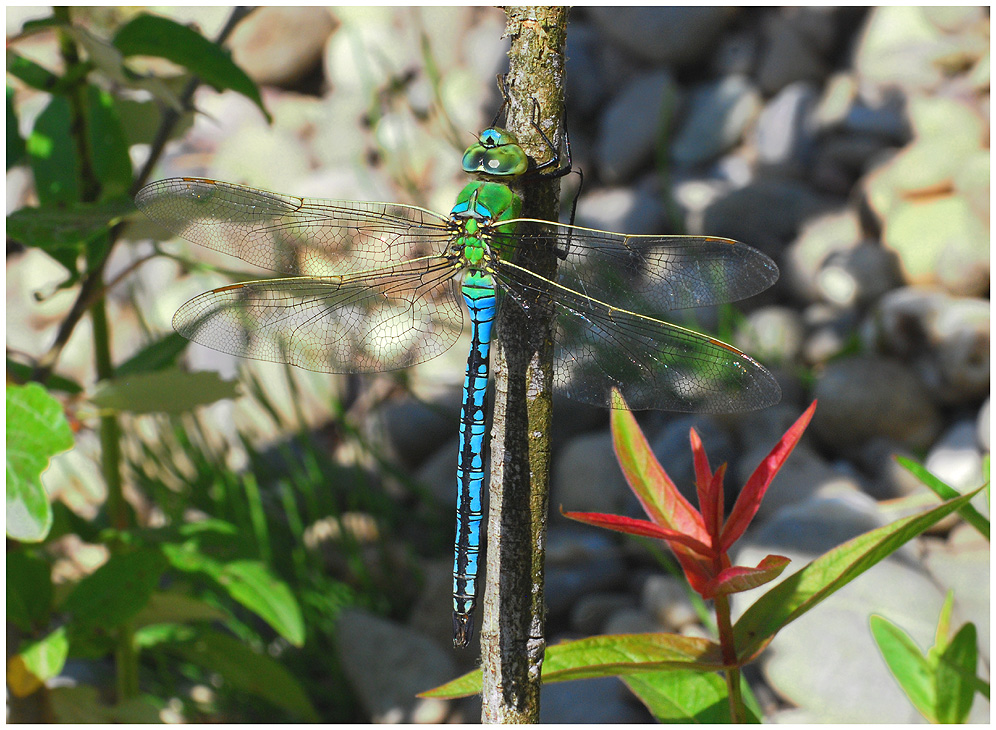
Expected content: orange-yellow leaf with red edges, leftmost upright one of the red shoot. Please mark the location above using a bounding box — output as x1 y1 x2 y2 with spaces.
611 391 709 544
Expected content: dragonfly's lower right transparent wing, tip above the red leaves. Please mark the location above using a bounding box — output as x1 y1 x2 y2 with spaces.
494 262 781 413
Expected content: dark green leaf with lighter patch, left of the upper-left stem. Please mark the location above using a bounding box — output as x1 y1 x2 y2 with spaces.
27 96 81 205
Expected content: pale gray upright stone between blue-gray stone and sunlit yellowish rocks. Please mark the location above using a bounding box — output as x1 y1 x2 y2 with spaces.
754 81 818 172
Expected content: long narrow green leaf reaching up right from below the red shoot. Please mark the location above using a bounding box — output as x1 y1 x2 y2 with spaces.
733 487 981 660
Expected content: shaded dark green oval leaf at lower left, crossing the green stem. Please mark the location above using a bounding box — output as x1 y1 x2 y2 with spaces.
62 548 167 629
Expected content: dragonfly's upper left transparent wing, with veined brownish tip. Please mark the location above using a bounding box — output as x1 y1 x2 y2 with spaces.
135 177 450 276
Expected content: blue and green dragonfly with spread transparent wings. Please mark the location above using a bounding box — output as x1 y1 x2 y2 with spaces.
135 98 781 647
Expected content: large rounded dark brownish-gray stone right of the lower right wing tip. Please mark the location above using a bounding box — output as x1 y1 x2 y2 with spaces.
812 357 941 450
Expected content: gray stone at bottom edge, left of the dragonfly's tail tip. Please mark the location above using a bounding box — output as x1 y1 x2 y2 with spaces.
336 609 466 723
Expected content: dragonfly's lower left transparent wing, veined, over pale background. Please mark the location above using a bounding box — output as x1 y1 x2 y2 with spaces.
173 256 463 373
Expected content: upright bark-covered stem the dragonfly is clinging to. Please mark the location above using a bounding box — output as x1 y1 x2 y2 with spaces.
481 7 567 723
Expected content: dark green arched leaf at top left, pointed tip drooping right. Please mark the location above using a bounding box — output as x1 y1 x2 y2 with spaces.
114 15 270 122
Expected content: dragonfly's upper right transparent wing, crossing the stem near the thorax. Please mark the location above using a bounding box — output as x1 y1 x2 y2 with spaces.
496 220 778 317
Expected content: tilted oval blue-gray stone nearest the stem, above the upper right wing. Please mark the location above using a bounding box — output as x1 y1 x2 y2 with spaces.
595 71 678 184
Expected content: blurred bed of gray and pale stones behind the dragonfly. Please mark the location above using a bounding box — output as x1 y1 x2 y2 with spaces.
8 7 990 722
